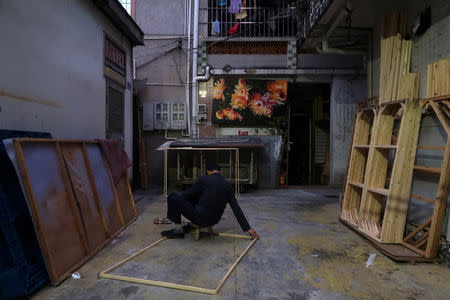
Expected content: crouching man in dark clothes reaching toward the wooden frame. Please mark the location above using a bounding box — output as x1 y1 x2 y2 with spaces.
161 163 259 238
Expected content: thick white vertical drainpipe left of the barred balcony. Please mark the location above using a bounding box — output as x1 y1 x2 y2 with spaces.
191 0 199 138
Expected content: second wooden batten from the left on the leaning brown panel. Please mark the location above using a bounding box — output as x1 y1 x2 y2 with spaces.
56 142 89 254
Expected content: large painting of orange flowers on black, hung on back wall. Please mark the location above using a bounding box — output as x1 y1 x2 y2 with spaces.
213 78 287 125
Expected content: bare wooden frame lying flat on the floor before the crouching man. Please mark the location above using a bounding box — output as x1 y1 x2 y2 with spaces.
99 233 258 295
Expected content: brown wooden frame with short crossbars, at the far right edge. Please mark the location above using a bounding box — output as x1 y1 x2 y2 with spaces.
402 96 450 258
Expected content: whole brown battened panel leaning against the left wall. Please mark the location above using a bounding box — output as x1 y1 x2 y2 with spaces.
4 138 136 285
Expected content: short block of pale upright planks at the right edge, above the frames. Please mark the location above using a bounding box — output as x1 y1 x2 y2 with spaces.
427 57 450 98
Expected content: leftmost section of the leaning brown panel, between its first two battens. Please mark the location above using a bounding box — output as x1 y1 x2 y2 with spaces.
22 143 86 281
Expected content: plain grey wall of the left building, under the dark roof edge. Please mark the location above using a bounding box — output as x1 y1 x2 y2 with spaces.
0 0 132 173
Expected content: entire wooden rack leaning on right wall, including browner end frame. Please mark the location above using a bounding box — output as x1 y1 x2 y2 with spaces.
340 95 450 261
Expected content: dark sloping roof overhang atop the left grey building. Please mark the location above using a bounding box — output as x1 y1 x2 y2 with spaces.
93 0 144 46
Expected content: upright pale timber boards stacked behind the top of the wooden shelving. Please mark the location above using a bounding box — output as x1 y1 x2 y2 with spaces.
379 34 419 103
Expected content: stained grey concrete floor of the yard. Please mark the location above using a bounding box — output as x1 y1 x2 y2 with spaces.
32 189 450 300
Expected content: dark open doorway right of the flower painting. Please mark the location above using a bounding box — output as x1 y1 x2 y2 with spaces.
287 83 330 186
